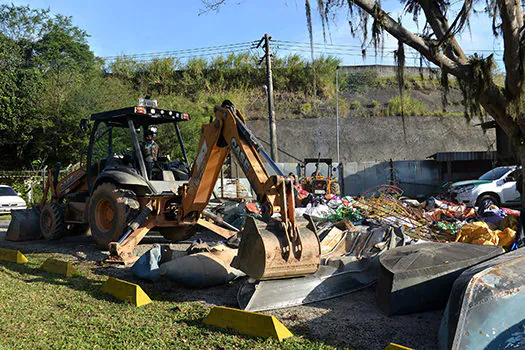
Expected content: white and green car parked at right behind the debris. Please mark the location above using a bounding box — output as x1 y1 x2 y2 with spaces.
451 166 521 207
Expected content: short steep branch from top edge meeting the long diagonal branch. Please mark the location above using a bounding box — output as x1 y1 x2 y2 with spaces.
418 0 468 64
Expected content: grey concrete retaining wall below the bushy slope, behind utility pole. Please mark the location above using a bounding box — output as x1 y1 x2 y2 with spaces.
248 116 495 163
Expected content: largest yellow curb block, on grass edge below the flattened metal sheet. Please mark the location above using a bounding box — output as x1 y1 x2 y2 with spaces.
204 306 293 342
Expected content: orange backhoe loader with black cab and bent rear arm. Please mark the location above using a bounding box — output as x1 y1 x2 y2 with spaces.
7 101 320 280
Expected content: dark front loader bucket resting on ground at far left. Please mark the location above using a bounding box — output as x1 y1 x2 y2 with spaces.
5 206 42 241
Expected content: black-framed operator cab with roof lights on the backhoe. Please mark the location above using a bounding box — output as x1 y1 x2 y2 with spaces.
87 99 190 194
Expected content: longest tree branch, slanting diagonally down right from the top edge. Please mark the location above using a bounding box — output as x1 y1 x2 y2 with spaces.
354 0 468 78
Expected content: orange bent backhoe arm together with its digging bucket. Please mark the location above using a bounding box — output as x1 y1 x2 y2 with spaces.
179 101 320 279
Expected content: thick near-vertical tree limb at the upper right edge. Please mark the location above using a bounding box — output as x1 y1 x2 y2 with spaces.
498 0 523 97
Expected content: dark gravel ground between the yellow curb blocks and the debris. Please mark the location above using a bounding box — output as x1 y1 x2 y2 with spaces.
0 220 443 349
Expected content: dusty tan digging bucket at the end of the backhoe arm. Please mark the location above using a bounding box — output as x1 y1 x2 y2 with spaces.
232 216 321 280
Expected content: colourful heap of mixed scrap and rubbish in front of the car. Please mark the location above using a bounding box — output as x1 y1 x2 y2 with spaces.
297 185 520 249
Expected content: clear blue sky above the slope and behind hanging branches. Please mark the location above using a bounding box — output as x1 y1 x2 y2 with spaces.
5 0 501 65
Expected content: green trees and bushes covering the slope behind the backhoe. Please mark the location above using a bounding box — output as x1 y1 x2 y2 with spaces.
0 5 461 169
